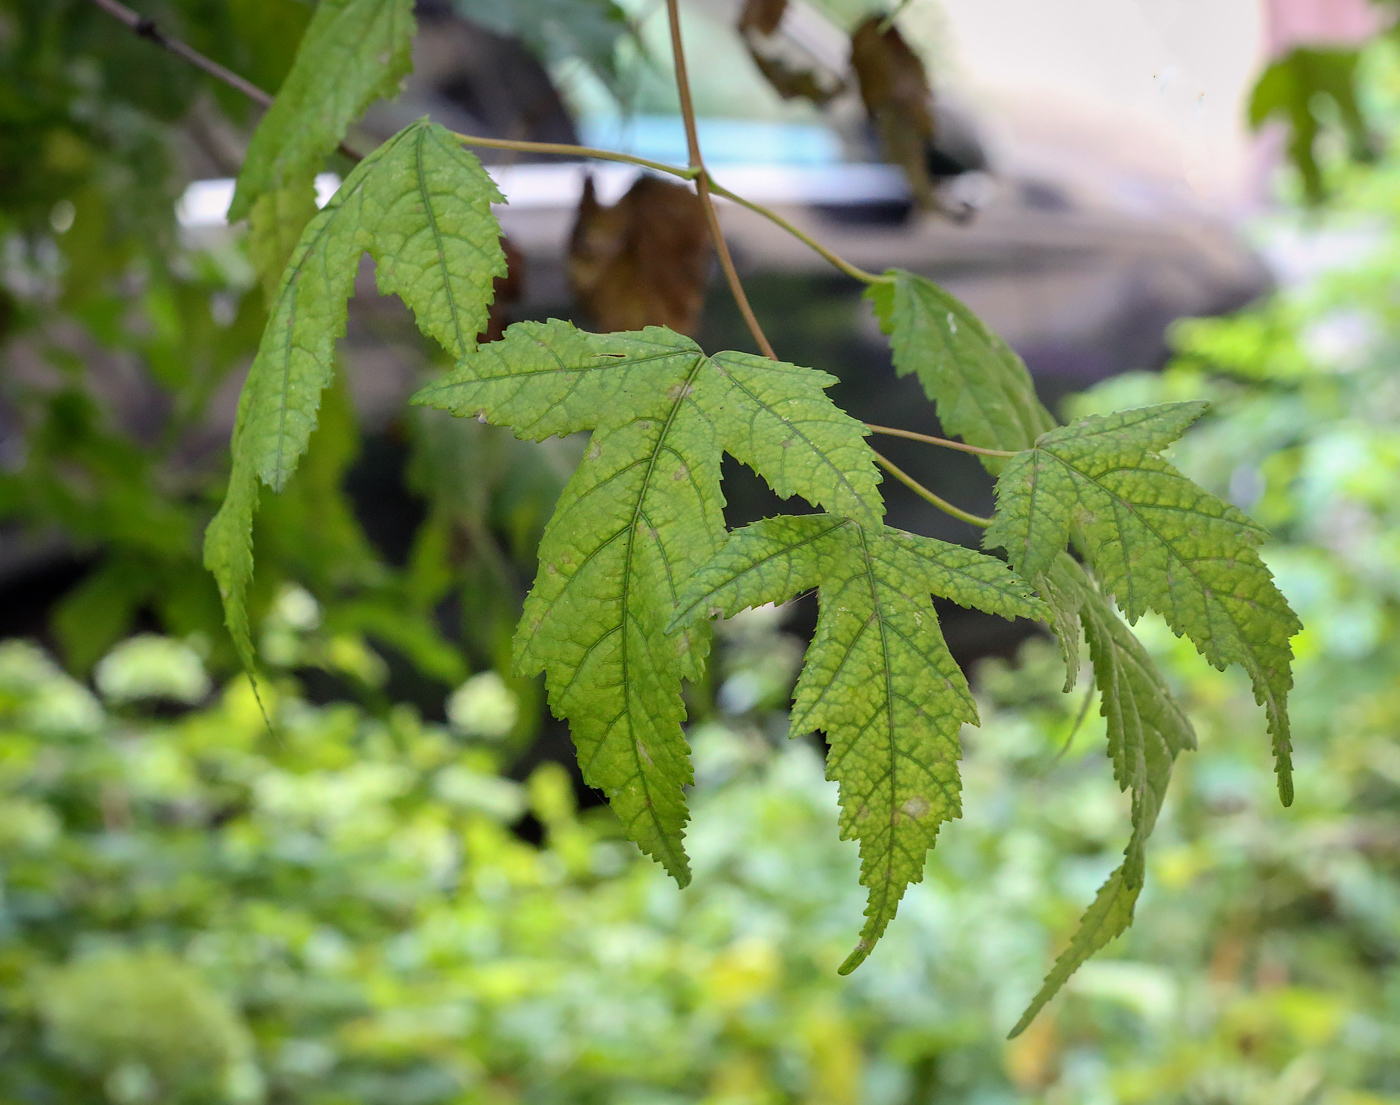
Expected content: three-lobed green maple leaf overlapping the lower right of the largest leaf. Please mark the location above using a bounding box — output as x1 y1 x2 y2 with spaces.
676 514 1044 973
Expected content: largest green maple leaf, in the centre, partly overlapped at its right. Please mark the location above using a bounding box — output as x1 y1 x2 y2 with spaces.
413 321 882 885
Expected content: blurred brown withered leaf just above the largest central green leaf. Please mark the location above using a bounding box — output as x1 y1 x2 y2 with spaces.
568 176 711 335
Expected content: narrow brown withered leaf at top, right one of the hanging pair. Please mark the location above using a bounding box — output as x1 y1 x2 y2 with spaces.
851 15 939 210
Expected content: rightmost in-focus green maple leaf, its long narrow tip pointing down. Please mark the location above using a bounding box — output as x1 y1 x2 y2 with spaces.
986 403 1301 805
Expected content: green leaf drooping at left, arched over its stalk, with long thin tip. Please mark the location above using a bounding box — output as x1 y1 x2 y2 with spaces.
204 120 505 669
